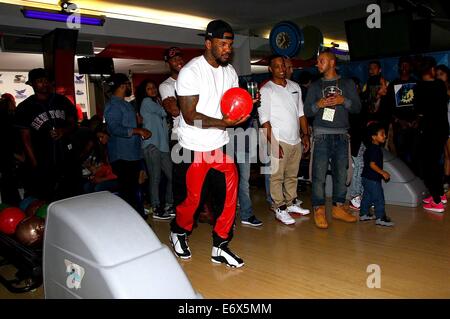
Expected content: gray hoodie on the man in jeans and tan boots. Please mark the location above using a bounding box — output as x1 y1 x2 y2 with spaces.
304 76 361 134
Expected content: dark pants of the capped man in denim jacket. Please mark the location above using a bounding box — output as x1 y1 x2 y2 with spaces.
111 160 145 216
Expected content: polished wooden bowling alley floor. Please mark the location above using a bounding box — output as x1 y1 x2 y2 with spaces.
0 188 450 299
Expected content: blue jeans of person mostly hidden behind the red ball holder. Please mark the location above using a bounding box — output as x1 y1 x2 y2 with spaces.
236 155 253 220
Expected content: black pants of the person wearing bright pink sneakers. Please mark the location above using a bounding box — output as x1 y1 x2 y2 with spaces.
420 136 447 203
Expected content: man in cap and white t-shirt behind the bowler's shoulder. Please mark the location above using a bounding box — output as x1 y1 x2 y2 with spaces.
159 47 184 140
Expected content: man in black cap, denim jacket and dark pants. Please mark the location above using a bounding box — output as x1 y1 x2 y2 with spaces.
105 73 151 218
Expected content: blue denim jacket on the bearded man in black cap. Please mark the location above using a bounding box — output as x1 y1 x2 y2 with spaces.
105 95 142 163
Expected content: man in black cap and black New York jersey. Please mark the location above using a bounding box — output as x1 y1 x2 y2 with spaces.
15 68 81 201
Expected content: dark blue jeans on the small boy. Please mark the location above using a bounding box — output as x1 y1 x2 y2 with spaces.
359 177 385 218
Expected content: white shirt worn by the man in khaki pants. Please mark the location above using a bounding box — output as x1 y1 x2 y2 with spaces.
258 80 303 145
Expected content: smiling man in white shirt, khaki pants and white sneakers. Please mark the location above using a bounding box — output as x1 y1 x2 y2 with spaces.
258 55 309 225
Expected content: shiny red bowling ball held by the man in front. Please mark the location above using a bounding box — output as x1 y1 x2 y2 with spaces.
220 88 253 120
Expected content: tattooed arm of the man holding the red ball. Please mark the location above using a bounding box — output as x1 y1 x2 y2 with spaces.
178 95 249 129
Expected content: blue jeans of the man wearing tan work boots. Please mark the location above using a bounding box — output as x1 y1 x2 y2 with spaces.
312 134 349 207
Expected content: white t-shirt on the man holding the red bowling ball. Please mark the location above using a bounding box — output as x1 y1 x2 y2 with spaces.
176 55 239 152
